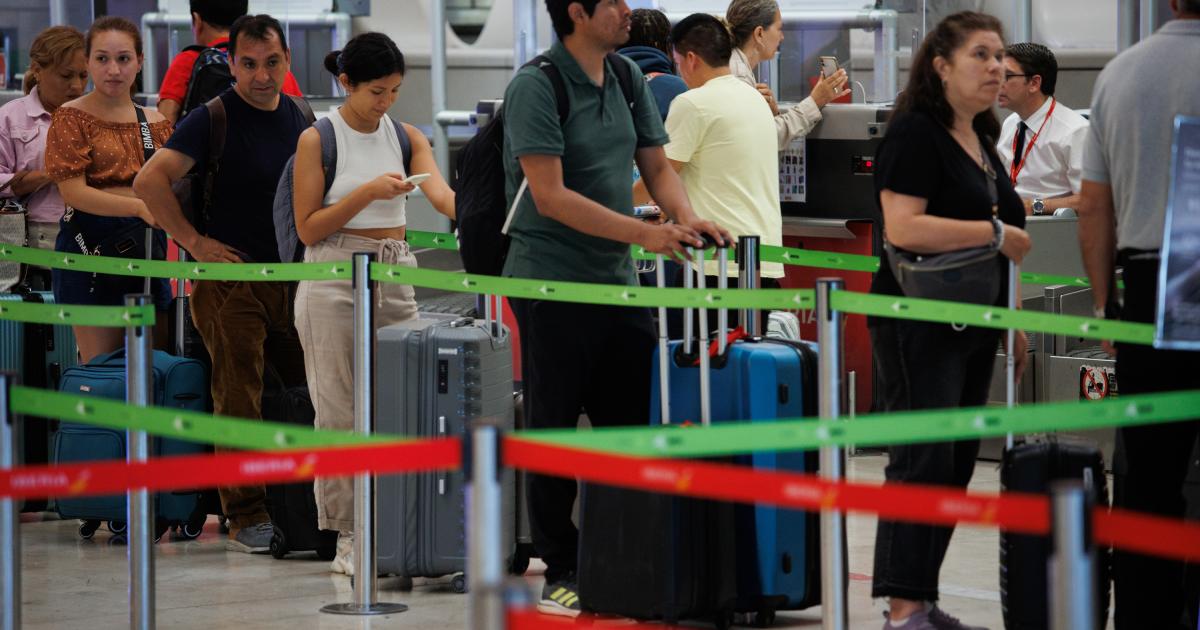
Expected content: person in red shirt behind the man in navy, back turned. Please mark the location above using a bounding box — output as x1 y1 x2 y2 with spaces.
158 0 304 124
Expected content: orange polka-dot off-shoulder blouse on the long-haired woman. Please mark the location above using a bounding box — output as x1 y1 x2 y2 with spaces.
46 107 172 188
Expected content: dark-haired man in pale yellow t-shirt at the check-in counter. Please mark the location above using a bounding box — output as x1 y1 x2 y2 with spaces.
634 13 784 282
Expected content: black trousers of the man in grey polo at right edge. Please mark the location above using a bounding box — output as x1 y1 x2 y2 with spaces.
1114 257 1200 630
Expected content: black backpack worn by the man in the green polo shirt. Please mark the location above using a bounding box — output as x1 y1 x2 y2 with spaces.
455 53 636 276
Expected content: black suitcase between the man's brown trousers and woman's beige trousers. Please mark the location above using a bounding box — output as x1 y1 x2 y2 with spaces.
263 366 337 560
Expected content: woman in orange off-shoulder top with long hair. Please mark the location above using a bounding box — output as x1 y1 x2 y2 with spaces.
46 17 172 362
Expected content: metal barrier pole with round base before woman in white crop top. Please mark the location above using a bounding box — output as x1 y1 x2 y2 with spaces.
320 252 408 614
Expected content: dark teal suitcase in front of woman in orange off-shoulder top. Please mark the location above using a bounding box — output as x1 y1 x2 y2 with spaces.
52 349 209 538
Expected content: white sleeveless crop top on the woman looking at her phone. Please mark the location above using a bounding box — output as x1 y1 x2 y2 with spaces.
324 108 408 229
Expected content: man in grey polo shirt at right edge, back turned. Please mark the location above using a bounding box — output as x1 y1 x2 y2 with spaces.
1079 0 1200 630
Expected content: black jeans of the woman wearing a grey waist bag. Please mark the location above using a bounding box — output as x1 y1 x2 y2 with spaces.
871 319 1001 601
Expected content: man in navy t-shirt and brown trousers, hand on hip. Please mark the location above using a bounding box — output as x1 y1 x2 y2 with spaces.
133 16 308 553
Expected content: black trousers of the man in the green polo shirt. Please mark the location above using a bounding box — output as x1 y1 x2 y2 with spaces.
510 300 655 582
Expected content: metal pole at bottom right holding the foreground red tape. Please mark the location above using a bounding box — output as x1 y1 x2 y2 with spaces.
1050 480 1096 630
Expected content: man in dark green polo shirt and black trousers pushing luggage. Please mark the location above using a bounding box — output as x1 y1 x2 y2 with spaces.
504 0 730 617
